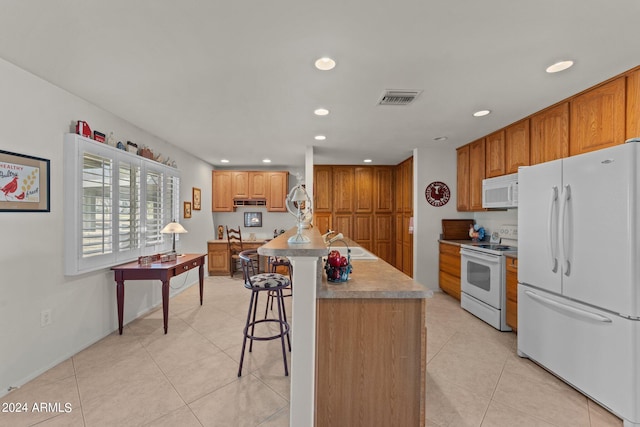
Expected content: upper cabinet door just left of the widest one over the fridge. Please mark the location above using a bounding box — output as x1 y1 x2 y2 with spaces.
531 102 569 165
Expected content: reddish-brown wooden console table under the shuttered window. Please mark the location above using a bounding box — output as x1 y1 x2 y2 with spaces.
111 254 207 335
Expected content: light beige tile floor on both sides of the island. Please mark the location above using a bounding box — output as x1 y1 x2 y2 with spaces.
0 277 622 427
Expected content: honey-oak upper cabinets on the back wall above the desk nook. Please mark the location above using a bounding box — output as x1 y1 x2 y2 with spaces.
211 170 289 212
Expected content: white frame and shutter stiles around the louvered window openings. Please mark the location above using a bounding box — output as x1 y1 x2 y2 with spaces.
64 133 180 275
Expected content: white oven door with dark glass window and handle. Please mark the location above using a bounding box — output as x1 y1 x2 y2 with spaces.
460 248 504 310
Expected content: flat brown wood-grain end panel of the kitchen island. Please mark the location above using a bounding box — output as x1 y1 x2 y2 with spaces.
315 298 427 427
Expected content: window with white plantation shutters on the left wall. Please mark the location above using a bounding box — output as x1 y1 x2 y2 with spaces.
64 134 180 275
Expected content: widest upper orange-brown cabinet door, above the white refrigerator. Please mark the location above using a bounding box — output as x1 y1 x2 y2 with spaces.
569 77 626 156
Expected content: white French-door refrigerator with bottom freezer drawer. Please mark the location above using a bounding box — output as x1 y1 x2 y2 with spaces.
518 143 640 427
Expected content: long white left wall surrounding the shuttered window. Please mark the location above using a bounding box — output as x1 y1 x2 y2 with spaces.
0 60 214 396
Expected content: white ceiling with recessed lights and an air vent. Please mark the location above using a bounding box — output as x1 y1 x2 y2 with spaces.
0 0 640 167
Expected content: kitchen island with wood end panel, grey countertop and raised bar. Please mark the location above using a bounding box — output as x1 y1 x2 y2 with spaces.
258 229 431 426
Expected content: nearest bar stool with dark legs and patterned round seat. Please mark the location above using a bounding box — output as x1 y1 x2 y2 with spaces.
238 249 291 376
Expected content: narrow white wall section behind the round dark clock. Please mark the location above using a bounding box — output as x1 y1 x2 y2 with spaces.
413 147 473 290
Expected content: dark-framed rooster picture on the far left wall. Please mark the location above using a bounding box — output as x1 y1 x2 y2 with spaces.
0 150 51 212
